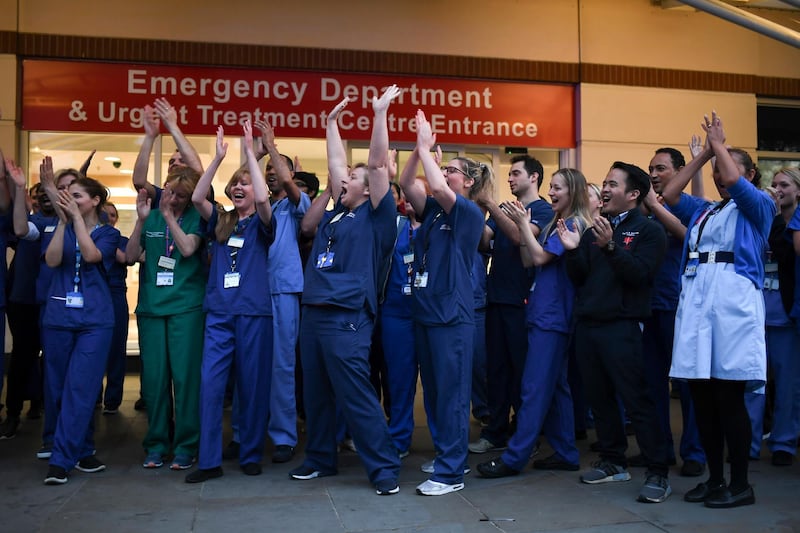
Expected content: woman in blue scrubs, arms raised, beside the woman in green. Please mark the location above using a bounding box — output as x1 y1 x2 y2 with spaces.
186 121 275 483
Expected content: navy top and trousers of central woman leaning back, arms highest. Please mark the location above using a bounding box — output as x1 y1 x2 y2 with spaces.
300 191 400 484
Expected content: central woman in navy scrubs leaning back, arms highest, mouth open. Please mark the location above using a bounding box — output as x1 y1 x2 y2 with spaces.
289 85 400 496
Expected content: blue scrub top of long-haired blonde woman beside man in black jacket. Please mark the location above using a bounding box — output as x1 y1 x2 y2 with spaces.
525 219 575 333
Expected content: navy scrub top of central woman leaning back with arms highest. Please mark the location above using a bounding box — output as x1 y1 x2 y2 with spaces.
302 189 397 316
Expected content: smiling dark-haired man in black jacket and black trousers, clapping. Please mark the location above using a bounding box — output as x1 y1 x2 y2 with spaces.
558 161 672 503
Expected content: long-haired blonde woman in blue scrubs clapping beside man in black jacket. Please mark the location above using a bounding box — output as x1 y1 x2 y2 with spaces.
478 168 590 477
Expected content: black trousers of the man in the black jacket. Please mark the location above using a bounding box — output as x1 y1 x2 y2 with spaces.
575 320 669 476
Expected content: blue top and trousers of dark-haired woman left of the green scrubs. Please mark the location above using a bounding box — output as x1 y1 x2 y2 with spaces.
42 222 119 471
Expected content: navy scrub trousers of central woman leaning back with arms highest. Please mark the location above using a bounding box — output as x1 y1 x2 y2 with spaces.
300 305 400 484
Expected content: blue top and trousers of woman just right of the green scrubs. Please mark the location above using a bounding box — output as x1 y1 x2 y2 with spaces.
198 209 275 469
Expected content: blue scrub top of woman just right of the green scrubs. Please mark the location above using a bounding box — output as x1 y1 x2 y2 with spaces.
203 209 275 316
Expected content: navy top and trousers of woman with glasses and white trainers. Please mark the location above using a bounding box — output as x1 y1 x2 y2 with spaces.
413 196 483 485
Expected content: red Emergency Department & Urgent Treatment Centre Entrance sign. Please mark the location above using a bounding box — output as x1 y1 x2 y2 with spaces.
22 60 575 148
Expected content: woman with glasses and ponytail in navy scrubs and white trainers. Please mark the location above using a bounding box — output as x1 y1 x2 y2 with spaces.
400 111 492 496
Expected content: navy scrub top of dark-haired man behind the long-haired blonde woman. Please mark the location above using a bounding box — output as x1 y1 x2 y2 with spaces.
487 198 553 307
